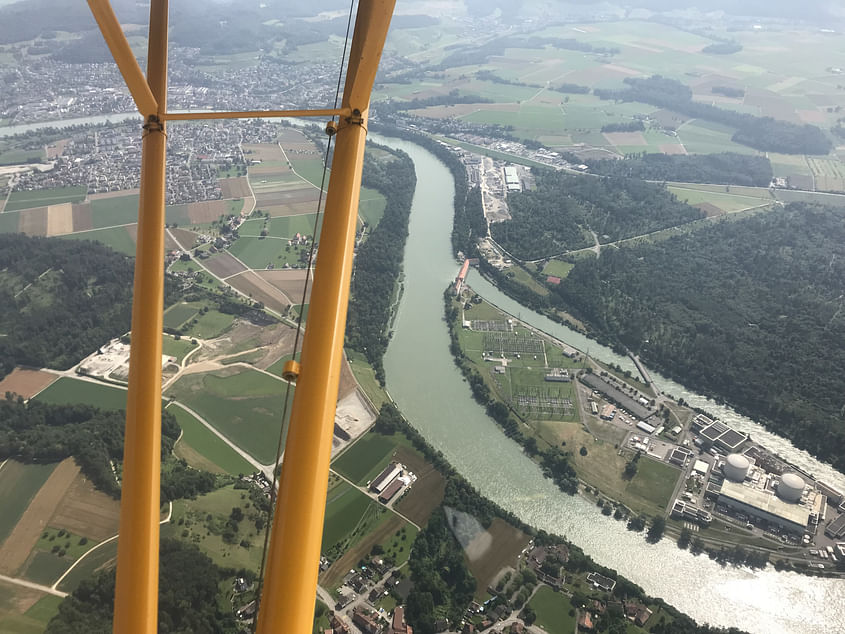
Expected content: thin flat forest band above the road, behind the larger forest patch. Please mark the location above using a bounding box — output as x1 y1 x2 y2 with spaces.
565 152 772 187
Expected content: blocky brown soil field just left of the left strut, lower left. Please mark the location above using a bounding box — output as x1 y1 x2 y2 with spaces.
50 473 120 541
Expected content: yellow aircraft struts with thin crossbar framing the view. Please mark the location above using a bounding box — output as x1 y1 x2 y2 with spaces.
88 0 396 634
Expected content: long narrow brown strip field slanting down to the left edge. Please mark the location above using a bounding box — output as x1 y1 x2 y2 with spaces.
0 458 79 575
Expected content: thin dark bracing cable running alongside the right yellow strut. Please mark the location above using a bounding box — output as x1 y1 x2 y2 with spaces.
252 0 355 633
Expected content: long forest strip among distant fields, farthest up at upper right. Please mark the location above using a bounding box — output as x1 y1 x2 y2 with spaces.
593 75 833 155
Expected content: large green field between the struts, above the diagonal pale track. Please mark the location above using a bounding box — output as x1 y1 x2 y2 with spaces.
168 368 290 464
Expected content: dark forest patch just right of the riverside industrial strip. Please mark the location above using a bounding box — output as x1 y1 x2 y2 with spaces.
490 169 701 260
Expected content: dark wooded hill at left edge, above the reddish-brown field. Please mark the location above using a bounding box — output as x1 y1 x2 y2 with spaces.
0 234 163 377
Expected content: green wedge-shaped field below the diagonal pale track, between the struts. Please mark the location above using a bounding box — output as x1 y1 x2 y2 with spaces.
167 403 255 475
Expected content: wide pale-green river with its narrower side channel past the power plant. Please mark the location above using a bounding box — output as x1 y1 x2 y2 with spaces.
374 137 845 634
